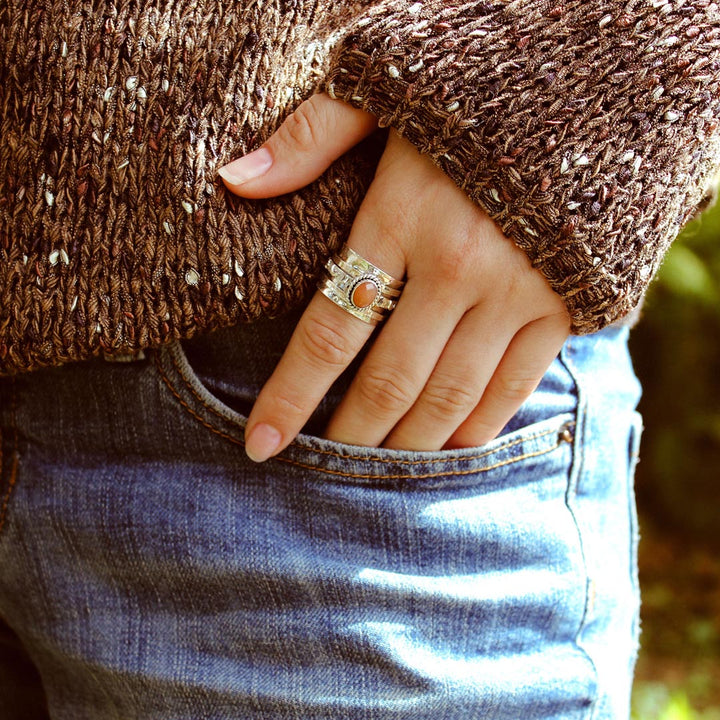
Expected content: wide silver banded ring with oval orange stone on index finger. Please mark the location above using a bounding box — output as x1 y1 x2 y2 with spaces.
318 245 405 325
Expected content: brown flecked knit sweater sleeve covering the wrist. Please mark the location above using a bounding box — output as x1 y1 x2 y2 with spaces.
321 0 720 334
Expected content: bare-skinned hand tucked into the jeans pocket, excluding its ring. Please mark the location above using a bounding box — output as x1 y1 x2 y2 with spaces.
221 94 570 461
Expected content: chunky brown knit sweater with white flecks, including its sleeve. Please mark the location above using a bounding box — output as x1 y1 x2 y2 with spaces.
0 0 720 373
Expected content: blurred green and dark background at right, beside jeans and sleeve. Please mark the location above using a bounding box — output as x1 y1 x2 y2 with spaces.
631 198 720 720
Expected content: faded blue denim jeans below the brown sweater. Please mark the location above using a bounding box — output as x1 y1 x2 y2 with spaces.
0 316 640 720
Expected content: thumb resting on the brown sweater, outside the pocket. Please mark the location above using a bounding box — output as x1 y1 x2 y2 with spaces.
218 93 377 198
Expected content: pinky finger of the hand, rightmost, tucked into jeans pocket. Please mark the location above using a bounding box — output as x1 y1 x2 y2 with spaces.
445 315 569 448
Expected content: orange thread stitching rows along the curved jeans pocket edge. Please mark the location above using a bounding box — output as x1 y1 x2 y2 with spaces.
155 352 560 480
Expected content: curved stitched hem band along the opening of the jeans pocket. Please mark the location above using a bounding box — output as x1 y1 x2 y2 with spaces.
156 343 574 487
